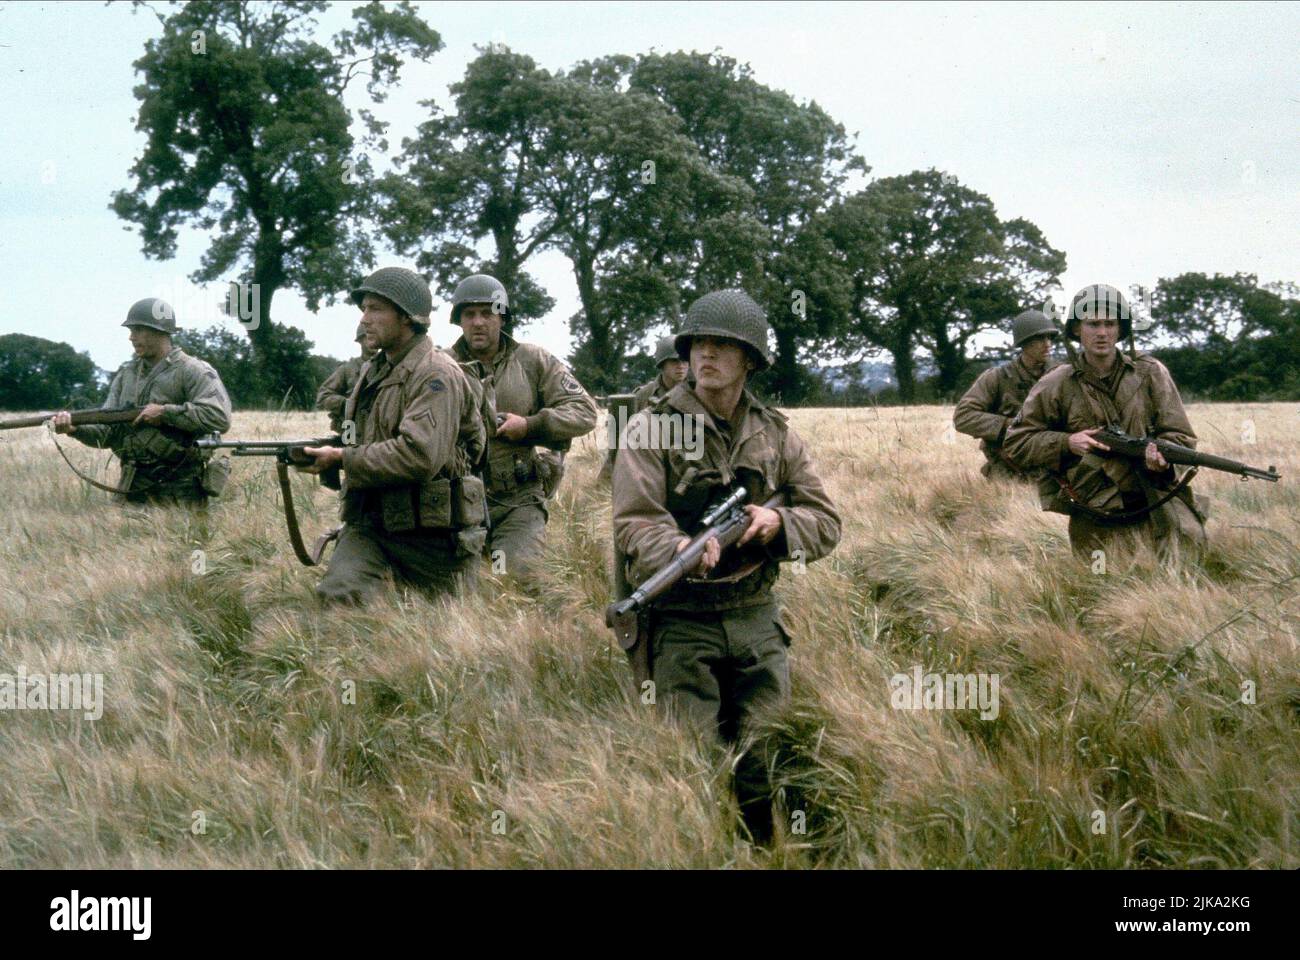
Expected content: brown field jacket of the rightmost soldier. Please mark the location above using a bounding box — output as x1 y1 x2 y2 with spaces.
1004 351 1196 514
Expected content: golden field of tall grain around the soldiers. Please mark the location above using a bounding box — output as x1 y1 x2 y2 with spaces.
0 405 1300 869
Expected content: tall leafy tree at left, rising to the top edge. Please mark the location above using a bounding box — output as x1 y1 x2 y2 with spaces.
112 0 442 403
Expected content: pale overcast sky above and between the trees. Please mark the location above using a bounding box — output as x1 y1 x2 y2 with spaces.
0 3 1300 369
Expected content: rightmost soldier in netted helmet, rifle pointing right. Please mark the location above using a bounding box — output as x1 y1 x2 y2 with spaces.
1005 284 1205 558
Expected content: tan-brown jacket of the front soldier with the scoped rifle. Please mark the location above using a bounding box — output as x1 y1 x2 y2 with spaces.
612 382 840 610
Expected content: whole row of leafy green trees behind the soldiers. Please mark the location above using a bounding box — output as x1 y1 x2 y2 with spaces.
5 3 1300 406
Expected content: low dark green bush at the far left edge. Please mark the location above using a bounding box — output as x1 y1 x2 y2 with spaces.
0 333 104 410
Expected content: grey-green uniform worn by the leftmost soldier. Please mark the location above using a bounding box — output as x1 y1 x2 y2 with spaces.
70 347 230 505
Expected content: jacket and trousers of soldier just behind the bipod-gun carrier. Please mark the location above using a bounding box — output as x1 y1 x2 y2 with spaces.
449 332 597 579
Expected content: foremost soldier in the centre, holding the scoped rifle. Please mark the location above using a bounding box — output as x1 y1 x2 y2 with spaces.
612 290 840 843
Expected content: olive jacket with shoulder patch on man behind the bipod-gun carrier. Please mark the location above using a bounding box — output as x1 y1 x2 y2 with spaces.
447 333 597 494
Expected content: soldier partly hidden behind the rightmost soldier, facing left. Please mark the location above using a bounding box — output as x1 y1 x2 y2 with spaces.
953 310 1057 481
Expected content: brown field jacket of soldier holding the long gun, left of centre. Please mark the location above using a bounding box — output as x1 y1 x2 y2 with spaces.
342 333 485 533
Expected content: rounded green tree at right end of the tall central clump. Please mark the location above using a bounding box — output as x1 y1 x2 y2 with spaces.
823 169 1065 403
